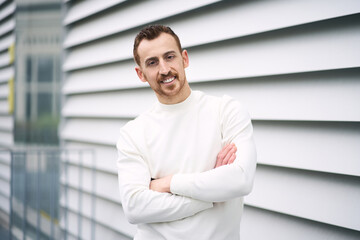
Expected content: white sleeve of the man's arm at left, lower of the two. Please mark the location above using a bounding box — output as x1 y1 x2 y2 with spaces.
117 125 213 224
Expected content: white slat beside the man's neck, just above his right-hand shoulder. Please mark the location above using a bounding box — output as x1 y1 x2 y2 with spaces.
192 69 360 121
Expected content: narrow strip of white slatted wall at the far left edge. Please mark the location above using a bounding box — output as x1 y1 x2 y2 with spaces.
0 0 16 231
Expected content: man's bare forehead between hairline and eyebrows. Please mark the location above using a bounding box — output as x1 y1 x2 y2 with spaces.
138 33 179 61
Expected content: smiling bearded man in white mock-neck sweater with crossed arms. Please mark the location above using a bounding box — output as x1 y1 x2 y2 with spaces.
117 25 256 240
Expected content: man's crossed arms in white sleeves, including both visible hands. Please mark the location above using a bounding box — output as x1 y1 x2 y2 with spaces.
117 96 256 224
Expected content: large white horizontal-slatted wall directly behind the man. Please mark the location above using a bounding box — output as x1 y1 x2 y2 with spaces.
61 0 360 239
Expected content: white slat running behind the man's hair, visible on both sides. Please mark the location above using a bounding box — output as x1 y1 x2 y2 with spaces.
64 0 360 70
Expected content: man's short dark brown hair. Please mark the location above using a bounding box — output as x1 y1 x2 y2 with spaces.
133 25 181 66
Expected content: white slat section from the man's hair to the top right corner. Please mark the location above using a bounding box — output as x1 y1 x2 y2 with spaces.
167 0 360 49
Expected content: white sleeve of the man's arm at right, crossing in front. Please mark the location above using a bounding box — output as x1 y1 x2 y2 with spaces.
170 97 256 202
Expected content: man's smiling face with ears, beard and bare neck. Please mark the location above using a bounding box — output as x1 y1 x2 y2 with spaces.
135 33 190 104
